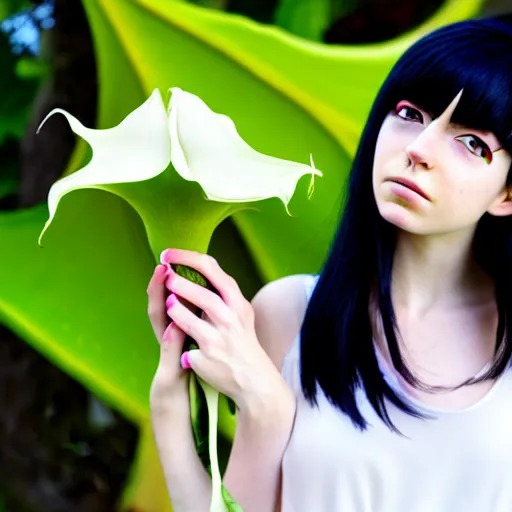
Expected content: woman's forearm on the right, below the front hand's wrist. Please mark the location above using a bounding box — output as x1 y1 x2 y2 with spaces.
224 382 295 512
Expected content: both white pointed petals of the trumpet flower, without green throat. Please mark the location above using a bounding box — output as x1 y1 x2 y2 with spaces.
38 88 322 245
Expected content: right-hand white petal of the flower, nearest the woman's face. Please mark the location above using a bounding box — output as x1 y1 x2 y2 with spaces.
169 88 322 213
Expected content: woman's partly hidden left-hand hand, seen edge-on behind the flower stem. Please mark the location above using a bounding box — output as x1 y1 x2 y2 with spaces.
147 265 188 412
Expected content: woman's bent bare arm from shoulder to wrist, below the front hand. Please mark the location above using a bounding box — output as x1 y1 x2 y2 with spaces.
224 276 305 512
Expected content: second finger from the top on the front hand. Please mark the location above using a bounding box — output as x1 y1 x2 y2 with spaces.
165 270 234 326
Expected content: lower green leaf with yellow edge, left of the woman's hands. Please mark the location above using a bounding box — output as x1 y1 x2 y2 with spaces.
0 190 259 512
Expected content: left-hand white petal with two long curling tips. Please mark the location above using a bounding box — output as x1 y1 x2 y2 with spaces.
38 89 170 243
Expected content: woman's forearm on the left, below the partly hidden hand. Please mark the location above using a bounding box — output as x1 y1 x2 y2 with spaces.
151 395 211 512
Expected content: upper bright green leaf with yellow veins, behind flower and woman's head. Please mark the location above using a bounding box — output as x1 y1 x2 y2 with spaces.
79 0 481 280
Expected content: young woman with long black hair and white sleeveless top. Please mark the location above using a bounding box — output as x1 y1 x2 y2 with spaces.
148 15 512 512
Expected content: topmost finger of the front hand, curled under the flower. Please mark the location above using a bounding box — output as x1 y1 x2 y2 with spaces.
160 249 247 313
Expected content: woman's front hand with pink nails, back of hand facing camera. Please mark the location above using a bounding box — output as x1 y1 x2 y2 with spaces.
161 249 282 409
